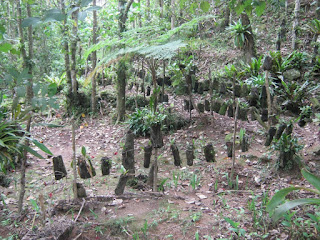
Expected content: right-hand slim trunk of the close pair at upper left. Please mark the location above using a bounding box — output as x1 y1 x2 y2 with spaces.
71 6 79 96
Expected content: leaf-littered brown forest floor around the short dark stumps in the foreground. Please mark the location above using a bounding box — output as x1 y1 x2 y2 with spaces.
0 86 320 240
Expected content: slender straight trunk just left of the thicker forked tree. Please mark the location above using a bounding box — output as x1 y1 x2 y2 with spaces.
91 0 97 112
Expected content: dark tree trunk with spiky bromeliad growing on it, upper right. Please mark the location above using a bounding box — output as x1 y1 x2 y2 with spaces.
241 13 256 63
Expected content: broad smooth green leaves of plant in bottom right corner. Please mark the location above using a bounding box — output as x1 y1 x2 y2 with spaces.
266 169 320 221
